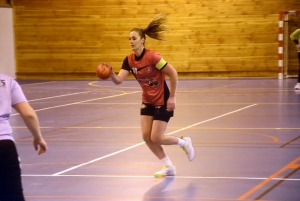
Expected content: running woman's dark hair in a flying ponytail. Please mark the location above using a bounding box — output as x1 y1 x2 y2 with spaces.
130 13 168 42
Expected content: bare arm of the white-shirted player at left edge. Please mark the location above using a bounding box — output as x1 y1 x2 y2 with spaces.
13 102 47 155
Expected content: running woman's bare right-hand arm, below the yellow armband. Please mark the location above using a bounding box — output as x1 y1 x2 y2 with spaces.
162 63 178 111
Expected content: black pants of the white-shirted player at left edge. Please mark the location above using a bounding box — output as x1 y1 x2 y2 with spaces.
0 140 25 201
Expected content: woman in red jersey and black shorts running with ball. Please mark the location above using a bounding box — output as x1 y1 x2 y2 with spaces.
103 14 196 177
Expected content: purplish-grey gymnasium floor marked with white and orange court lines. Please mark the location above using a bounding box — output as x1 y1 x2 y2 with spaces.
11 78 300 201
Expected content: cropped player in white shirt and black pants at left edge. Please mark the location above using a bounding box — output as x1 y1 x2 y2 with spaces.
0 73 47 201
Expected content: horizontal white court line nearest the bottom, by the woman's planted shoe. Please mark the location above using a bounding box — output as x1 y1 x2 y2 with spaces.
22 174 300 181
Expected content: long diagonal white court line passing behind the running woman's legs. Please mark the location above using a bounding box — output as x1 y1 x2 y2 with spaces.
53 104 257 176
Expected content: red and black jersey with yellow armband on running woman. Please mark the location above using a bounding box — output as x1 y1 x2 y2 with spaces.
122 49 170 106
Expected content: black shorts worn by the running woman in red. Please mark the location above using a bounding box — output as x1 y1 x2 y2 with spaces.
141 103 174 122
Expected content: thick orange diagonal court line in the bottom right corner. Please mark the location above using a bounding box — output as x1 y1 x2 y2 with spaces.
238 157 300 200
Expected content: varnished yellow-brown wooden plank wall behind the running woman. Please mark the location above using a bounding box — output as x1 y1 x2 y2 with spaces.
13 0 300 79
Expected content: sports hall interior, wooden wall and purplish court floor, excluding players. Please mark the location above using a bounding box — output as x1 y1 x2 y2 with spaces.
0 0 300 201
